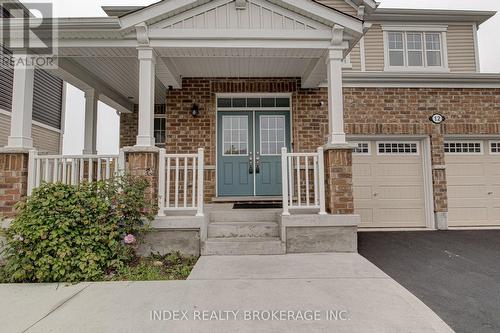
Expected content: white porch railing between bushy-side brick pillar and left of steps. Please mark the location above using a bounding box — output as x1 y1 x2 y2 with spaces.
158 148 204 216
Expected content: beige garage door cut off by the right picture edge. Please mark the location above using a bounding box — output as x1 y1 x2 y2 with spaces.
445 140 500 227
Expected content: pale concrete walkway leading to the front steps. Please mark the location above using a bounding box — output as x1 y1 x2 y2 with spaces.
0 254 452 333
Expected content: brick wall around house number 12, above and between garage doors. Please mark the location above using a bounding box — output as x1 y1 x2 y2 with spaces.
344 88 500 212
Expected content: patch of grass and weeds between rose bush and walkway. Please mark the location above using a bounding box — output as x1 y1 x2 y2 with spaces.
106 252 198 281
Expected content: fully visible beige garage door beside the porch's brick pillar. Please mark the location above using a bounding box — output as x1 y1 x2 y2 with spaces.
353 141 426 228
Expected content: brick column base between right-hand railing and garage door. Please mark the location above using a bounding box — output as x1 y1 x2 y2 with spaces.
324 143 356 215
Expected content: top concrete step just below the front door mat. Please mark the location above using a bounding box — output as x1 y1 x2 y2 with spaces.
210 209 281 222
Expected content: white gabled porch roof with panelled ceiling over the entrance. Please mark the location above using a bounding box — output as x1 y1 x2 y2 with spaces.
20 0 367 111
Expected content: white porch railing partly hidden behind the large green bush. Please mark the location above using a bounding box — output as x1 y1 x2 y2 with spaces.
28 150 125 195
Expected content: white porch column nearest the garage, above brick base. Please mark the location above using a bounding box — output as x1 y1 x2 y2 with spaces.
326 48 346 144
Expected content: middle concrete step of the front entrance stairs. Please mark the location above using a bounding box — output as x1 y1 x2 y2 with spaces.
208 221 279 238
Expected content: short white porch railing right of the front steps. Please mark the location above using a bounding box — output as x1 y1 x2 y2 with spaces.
281 147 326 215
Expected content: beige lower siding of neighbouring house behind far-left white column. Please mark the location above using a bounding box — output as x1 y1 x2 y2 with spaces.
0 114 61 154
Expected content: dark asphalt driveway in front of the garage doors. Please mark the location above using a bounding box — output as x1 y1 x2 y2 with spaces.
359 230 500 333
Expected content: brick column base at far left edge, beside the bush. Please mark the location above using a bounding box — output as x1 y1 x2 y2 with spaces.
0 148 29 218
